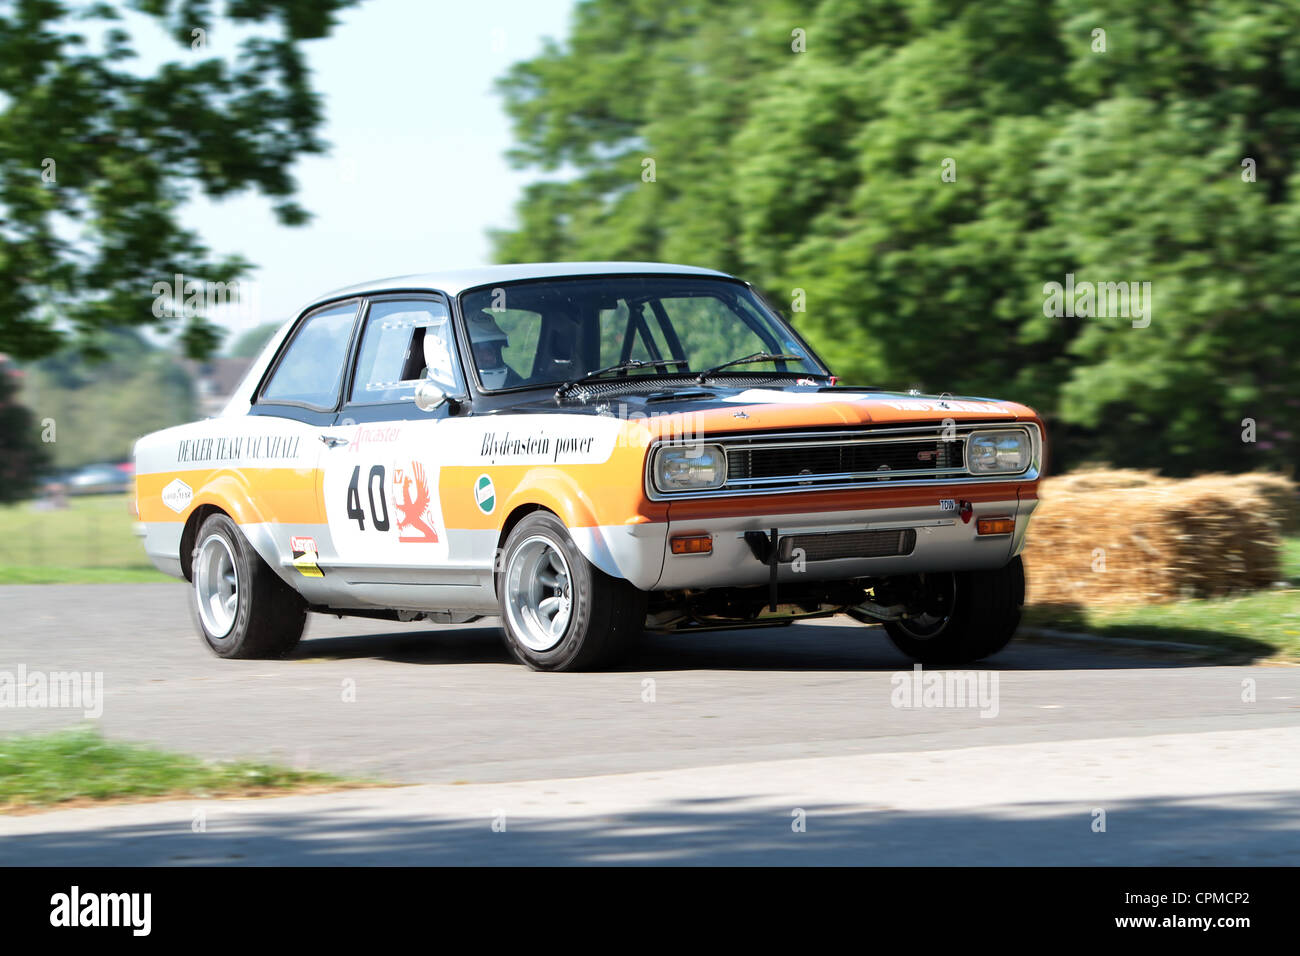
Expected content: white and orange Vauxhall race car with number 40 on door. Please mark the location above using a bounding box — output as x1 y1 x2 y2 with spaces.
135 263 1044 670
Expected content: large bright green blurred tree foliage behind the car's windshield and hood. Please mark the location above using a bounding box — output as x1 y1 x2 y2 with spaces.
495 0 1300 472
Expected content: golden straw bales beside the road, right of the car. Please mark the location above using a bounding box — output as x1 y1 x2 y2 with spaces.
1024 472 1295 605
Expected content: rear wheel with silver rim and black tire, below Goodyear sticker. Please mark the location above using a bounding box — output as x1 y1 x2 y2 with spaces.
190 514 307 658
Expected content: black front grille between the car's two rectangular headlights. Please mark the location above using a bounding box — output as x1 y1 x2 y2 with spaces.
727 436 966 490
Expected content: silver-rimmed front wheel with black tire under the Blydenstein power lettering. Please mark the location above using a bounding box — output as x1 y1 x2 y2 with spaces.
497 511 646 671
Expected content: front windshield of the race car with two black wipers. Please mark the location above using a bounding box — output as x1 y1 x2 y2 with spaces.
460 276 824 390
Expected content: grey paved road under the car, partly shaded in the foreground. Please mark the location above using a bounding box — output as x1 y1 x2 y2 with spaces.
0 584 1300 864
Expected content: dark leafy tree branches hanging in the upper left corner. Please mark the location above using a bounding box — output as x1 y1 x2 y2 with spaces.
0 0 356 359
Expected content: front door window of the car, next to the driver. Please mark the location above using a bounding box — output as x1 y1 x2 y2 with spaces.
351 299 460 405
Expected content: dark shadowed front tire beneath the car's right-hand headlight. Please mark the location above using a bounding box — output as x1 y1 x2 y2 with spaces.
885 555 1024 663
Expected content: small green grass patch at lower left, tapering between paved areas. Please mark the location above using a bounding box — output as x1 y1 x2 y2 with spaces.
0 728 365 813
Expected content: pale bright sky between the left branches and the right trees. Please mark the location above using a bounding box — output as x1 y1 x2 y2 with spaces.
172 0 573 337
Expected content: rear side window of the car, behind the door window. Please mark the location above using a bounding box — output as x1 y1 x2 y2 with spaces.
260 300 356 411
